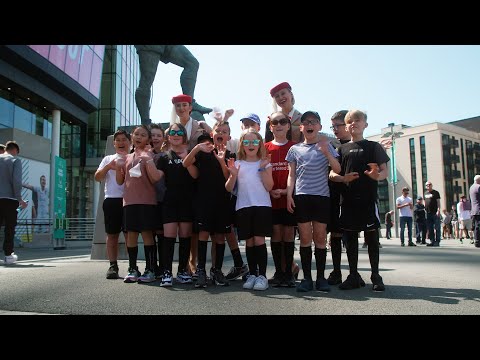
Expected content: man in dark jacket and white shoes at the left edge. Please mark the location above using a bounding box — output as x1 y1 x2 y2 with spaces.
0 141 27 265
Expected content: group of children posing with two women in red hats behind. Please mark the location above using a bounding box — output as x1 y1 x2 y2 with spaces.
95 83 389 292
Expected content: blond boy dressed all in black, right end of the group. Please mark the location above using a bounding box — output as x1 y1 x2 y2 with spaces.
330 110 390 291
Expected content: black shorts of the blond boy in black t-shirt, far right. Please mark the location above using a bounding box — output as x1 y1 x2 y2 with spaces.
340 201 380 231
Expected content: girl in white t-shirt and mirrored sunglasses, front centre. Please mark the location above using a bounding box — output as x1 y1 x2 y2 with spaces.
225 128 273 290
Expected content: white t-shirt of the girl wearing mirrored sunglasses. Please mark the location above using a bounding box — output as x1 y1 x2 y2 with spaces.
235 160 272 210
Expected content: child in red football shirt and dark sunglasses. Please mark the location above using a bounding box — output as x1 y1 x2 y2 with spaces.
265 111 297 287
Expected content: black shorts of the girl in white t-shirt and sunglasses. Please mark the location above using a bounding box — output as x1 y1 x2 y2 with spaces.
235 206 273 240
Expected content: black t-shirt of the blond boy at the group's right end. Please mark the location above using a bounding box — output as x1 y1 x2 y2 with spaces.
338 139 390 204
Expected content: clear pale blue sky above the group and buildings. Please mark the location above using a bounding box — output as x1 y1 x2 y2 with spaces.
151 45 480 141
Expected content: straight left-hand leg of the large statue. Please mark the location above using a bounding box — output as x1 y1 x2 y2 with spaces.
135 51 160 125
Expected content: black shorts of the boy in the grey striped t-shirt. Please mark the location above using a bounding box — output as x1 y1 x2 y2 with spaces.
294 195 330 224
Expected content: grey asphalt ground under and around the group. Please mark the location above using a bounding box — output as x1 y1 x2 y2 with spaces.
0 238 480 315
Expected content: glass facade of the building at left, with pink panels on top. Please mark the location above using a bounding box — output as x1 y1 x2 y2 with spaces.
0 45 140 218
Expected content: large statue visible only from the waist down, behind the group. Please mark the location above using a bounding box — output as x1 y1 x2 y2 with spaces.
134 45 212 125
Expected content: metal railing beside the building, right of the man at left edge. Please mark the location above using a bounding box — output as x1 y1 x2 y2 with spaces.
15 218 95 242
